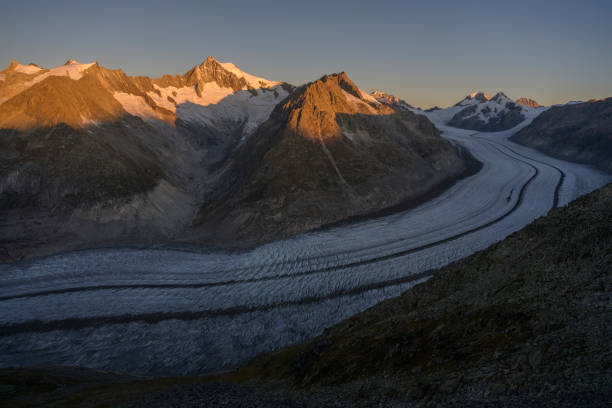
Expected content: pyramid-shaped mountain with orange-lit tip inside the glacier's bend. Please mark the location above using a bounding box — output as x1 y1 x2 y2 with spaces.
198 73 477 242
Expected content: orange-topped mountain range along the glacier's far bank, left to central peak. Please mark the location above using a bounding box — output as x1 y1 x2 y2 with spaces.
0 57 479 259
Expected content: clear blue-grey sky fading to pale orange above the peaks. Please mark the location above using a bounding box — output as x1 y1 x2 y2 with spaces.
0 0 612 107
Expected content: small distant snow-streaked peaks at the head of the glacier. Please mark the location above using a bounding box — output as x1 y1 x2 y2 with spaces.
447 92 529 132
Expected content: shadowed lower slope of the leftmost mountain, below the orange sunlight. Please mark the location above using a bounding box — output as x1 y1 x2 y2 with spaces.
0 116 198 261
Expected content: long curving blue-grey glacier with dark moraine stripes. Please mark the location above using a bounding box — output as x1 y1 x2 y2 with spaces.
0 110 612 375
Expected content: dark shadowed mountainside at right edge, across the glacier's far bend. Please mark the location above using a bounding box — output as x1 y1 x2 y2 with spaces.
511 98 612 173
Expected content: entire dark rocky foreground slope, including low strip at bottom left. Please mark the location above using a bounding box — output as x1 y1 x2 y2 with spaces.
0 185 612 407
